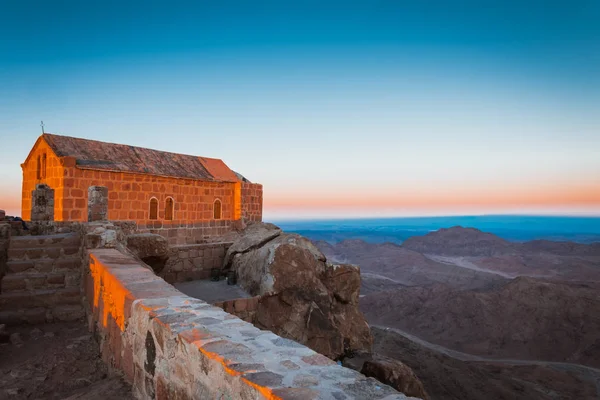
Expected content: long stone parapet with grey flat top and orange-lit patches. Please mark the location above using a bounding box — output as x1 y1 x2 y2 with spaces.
85 249 406 400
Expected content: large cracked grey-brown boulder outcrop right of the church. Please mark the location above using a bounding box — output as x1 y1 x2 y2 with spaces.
229 224 372 359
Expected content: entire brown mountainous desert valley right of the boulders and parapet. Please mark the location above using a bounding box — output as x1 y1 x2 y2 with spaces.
315 227 600 400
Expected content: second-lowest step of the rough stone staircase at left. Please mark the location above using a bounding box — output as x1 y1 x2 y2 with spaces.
0 288 81 311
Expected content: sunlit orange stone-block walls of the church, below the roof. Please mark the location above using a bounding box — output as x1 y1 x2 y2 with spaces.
21 136 262 226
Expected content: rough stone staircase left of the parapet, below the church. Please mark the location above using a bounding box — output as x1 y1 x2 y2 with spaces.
0 233 84 325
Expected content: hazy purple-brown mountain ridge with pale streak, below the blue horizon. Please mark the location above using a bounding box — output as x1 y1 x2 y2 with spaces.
315 226 600 289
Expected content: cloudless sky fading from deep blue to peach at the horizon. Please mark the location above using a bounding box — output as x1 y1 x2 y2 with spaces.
0 0 600 219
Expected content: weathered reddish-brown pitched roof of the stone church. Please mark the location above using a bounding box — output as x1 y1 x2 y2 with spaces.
42 133 238 182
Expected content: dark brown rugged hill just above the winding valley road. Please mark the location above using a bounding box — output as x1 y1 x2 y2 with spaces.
360 277 600 368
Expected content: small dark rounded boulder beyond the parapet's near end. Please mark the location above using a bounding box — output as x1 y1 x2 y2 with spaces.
360 356 429 400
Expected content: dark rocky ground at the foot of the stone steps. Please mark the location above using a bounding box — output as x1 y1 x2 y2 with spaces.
0 322 133 400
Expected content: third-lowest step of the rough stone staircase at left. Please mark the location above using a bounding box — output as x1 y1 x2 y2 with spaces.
0 271 81 293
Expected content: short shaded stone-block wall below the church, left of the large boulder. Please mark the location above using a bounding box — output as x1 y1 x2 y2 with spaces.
160 242 231 283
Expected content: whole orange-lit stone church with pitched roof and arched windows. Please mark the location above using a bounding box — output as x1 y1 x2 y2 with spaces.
21 133 262 234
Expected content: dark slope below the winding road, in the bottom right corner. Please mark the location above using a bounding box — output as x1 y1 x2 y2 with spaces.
372 328 600 400
